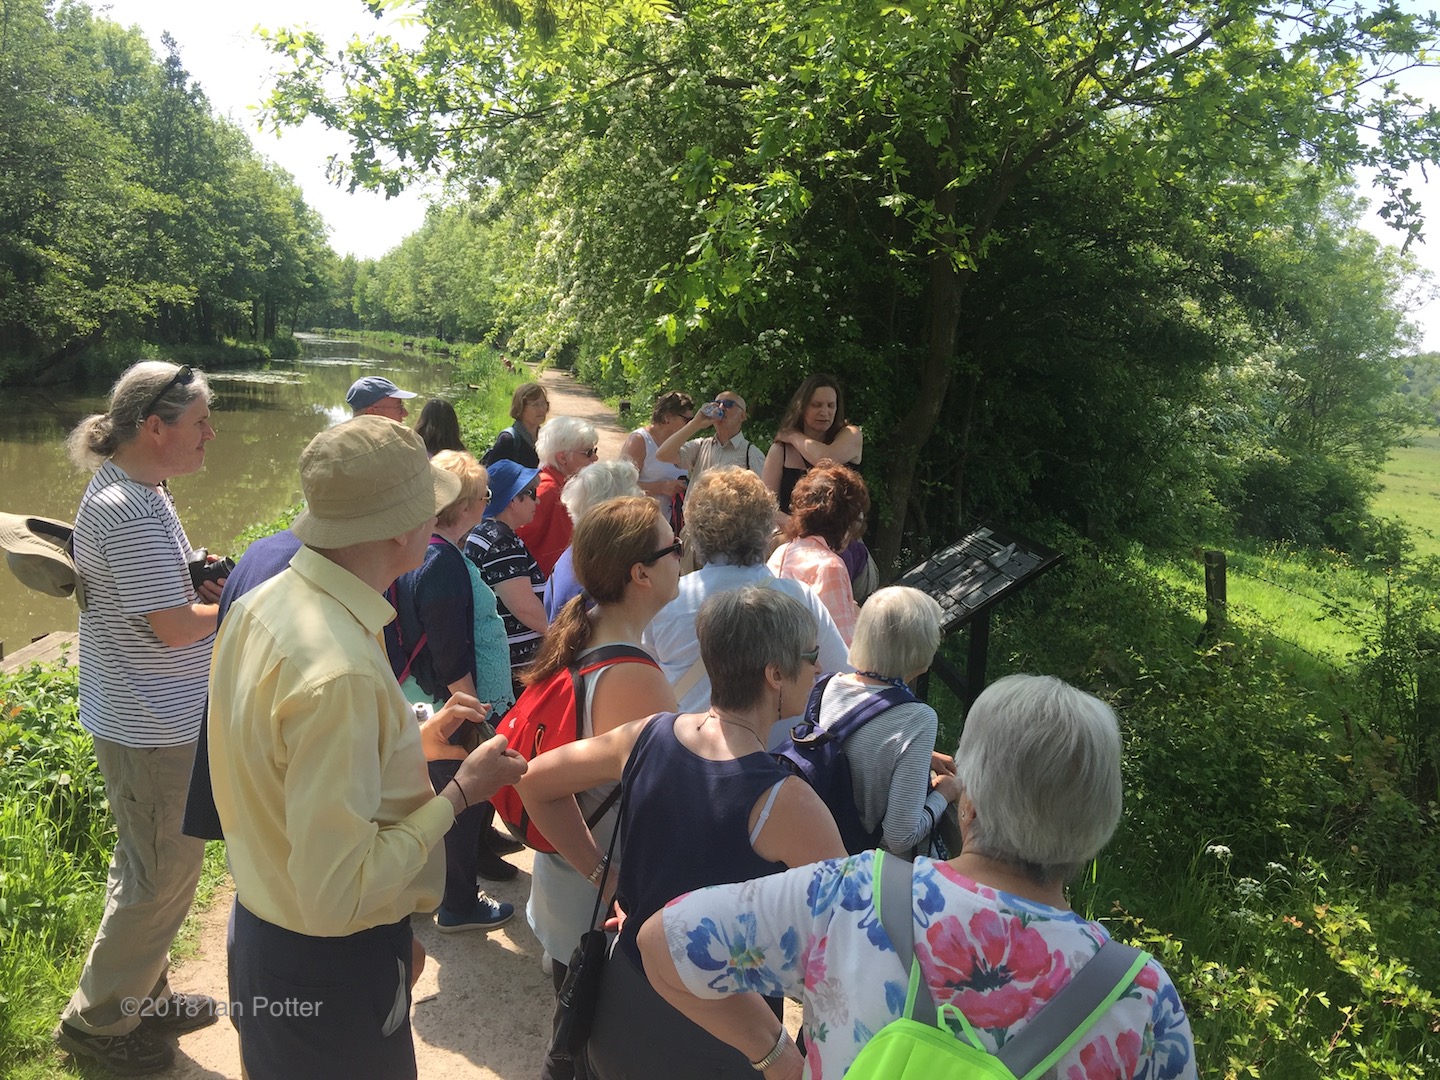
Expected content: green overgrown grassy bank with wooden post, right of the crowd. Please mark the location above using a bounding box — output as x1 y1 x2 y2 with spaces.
967 534 1440 1080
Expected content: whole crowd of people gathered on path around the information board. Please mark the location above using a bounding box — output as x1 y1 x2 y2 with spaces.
42 361 1195 1080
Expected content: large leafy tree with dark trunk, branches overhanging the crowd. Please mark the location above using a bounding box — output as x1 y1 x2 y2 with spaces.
274 0 1437 560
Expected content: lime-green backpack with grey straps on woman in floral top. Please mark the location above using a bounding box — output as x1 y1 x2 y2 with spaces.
845 851 1151 1080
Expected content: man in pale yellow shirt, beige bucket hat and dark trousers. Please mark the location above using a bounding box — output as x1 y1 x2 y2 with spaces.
209 416 524 1080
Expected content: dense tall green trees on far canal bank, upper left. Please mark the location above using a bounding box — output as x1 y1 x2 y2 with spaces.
0 0 327 379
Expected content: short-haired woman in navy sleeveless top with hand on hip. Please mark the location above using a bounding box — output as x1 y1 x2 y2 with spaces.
516 587 844 1080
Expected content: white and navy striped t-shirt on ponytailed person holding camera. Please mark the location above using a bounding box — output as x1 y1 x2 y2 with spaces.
75 461 215 747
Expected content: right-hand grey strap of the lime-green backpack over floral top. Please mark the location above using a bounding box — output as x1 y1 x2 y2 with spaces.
1002 937 1151 1077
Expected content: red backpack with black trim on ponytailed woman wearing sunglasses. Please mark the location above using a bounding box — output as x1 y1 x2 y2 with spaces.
491 645 660 855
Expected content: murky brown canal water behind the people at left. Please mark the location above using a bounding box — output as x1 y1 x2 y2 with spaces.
0 334 456 654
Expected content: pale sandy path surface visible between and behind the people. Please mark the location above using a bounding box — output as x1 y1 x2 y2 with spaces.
166 372 649 1080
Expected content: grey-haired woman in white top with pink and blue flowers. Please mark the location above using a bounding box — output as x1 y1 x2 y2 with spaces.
639 675 1197 1080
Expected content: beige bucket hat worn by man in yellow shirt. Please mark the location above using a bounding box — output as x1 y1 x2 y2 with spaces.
289 416 461 547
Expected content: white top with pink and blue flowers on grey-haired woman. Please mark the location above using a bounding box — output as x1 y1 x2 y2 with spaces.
664 852 1195 1080
